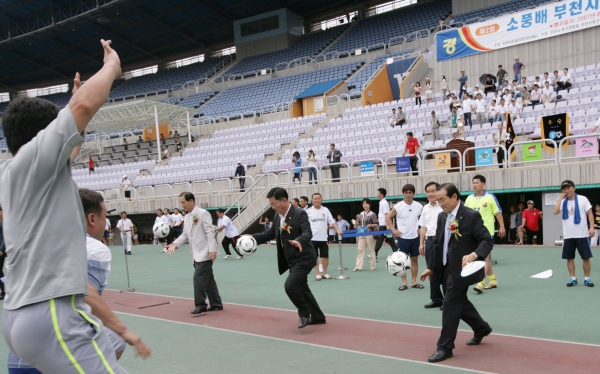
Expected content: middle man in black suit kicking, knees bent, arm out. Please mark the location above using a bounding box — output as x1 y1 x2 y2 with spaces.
252 187 325 329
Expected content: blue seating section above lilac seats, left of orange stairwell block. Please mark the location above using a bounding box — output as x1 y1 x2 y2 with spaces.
200 61 364 117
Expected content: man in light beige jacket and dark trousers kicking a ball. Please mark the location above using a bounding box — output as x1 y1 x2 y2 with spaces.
167 192 223 314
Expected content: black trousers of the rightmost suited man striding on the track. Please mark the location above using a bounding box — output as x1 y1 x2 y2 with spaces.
437 266 489 352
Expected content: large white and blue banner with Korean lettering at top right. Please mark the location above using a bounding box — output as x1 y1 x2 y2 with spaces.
436 0 600 60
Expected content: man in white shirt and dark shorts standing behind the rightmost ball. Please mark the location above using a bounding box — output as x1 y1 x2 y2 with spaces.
386 184 424 291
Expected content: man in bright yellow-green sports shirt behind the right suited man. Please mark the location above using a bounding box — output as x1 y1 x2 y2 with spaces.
465 175 506 293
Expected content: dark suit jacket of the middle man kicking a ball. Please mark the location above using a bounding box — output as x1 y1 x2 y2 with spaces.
252 205 317 274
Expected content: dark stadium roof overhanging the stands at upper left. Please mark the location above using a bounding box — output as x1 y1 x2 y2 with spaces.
0 0 356 91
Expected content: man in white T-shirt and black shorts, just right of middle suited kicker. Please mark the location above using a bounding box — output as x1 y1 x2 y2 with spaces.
306 192 343 281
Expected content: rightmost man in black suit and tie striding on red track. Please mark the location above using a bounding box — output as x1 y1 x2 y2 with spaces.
421 183 494 362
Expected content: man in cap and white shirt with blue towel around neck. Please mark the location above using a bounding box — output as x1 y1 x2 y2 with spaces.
552 180 596 287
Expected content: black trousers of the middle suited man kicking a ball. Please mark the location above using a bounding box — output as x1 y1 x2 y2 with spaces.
284 261 325 321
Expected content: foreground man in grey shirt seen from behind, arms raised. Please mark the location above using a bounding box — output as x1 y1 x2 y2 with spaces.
0 40 130 373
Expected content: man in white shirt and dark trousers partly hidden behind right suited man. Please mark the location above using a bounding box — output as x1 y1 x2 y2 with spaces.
419 182 444 309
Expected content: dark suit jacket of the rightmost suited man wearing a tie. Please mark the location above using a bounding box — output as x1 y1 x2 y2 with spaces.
427 202 494 287
